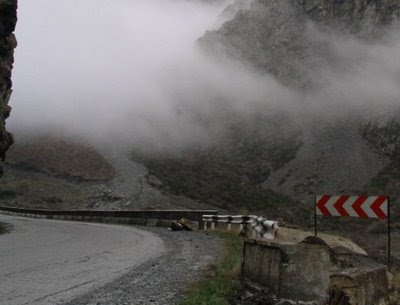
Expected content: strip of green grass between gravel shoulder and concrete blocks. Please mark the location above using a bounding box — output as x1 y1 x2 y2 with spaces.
180 233 243 305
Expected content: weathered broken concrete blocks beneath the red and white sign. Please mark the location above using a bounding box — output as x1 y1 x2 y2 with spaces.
242 237 389 305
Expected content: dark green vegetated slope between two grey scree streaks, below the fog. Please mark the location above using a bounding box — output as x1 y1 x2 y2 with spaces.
134 118 302 221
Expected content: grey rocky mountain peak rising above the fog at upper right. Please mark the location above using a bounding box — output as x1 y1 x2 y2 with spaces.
199 0 400 88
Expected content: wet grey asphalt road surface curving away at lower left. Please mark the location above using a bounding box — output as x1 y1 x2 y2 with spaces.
0 215 165 305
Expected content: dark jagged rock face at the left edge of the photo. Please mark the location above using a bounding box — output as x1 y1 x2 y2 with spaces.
0 0 17 176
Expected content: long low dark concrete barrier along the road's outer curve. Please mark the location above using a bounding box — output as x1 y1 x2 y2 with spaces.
0 206 218 227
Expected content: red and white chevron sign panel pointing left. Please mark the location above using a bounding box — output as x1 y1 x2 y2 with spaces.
316 195 389 219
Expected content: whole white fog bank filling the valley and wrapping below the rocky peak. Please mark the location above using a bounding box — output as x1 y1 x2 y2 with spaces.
8 0 400 152
